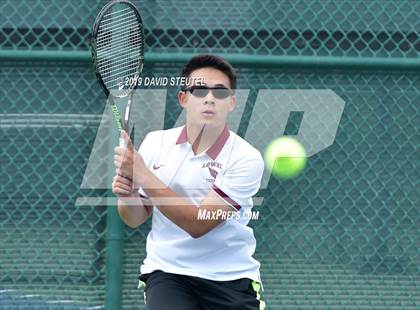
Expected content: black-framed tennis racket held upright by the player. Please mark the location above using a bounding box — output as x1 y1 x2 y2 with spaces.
91 0 144 147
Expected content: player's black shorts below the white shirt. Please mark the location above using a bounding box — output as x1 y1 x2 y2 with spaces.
140 270 264 310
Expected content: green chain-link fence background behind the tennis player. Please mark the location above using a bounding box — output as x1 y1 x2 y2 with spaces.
0 0 420 309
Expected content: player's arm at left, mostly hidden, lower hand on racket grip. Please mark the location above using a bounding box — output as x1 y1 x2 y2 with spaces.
112 175 153 228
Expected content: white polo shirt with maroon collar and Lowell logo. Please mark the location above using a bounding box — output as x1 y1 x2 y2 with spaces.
139 126 264 282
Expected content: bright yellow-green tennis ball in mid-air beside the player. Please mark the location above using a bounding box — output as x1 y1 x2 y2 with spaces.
264 136 306 179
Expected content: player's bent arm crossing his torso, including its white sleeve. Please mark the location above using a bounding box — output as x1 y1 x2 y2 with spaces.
141 159 264 238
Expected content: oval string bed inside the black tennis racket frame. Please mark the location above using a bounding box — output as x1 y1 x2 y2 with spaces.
96 3 143 95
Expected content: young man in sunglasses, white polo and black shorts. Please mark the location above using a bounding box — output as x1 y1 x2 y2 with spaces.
112 55 264 310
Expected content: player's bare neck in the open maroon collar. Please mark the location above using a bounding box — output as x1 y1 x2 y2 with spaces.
187 124 225 154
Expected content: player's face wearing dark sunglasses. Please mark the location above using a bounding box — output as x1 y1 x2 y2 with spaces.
179 68 236 128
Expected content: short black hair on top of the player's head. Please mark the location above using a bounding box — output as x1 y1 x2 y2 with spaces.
181 54 236 89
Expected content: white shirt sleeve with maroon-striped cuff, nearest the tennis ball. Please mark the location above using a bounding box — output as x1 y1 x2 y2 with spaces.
212 153 264 212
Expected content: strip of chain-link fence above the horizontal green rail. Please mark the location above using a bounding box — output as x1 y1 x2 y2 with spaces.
0 0 420 58
